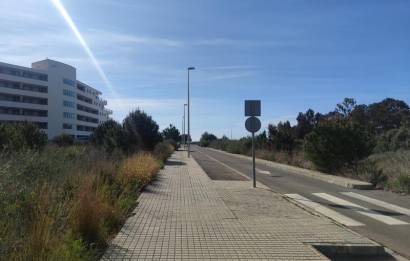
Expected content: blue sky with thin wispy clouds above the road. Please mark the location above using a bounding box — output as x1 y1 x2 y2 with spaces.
0 0 410 139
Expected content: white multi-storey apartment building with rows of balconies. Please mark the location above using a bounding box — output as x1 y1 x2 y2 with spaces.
0 59 112 139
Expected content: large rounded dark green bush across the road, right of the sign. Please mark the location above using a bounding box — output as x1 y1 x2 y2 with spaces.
305 122 373 173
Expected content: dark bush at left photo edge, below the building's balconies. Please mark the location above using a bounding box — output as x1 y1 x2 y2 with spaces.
0 122 47 152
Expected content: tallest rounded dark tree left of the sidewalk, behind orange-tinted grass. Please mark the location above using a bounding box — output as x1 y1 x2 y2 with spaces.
123 109 161 152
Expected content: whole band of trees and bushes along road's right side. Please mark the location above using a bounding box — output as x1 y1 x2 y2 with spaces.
200 98 410 194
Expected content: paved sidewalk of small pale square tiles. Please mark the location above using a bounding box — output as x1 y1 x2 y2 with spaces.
102 149 382 260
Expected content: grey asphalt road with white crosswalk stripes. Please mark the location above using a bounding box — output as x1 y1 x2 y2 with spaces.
191 146 410 258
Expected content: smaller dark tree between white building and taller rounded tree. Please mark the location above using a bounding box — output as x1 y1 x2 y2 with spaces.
90 120 124 152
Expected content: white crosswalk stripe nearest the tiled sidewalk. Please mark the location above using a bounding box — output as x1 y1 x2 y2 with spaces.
285 194 364 227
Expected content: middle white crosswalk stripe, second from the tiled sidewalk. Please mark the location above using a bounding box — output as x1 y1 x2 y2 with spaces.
313 193 408 225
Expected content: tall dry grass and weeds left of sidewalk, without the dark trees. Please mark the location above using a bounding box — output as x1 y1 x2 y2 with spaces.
0 146 168 260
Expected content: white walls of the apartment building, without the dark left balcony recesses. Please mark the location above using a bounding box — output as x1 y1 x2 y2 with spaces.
0 59 112 139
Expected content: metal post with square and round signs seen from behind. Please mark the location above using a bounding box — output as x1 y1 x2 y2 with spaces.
245 100 261 188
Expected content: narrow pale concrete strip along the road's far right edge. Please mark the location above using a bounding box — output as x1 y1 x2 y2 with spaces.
207 148 373 190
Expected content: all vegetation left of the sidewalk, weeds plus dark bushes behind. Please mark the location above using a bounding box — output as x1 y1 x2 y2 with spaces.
0 110 179 260
